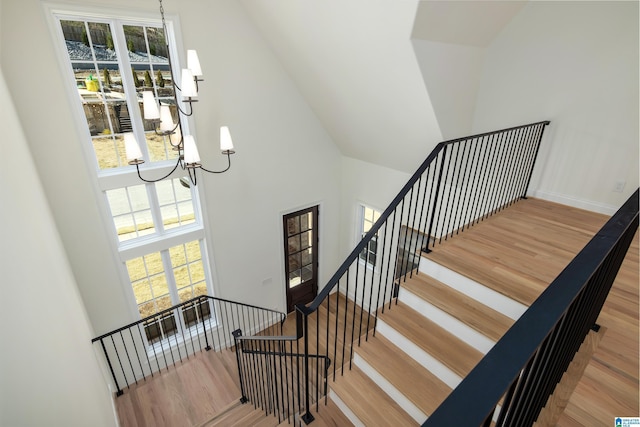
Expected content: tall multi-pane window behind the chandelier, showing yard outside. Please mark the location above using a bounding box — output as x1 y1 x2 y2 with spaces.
54 12 210 342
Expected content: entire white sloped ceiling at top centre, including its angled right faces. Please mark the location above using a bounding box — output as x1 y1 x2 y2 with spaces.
242 0 522 172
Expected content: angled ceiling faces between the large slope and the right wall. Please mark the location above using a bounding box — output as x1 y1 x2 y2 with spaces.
411 1 526 139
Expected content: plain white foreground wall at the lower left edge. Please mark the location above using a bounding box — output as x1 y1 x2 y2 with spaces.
0 64 117 427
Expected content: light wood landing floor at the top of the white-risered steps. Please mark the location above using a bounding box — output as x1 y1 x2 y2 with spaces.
423 198 607 306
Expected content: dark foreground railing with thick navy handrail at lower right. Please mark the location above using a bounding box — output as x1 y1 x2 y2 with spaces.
422 190 639 427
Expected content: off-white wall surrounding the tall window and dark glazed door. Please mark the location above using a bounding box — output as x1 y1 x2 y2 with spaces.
0 0 341 342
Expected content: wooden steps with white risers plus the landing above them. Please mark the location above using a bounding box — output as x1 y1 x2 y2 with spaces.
206 200 616 426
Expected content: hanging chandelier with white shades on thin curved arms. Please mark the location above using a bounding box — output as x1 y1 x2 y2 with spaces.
124 0 235 186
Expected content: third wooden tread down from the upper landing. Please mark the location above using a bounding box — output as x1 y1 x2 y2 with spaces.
356 334 451 416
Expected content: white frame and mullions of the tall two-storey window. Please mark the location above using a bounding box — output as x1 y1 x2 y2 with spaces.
43 2 216 348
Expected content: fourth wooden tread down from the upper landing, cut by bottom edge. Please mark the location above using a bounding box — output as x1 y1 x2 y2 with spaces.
331 366 418 426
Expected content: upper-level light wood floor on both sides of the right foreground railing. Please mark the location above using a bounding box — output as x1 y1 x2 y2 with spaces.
428 199 640 427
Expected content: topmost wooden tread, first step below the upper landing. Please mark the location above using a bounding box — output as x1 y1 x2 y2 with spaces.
401 274 514 342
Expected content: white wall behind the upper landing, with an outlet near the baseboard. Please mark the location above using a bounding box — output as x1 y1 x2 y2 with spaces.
474 1 639 213
